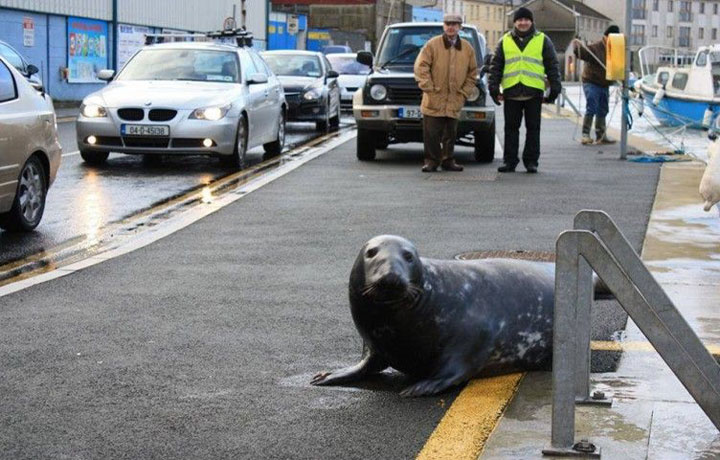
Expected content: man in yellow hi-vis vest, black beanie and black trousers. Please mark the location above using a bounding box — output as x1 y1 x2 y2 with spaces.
488 7 562 173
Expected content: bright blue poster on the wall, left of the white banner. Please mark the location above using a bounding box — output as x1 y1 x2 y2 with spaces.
67 17 108 83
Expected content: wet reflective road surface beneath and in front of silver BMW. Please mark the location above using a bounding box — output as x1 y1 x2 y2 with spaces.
0 117 353 273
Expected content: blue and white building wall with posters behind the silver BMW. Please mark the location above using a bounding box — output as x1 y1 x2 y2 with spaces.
0 0 269 101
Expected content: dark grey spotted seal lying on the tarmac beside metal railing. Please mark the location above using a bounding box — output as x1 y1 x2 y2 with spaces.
310 235 555 397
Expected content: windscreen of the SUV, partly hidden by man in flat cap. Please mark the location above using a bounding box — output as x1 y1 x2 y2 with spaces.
375 24 480 67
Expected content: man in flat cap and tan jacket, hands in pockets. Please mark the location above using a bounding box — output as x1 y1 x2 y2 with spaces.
415 14 477 172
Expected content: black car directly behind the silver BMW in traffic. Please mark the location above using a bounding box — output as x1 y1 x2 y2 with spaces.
261 50 340 131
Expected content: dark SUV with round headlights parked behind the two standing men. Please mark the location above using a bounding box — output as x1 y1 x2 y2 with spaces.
353 22 495 163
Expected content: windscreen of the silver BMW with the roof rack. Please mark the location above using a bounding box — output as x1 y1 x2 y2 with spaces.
117 49 240 83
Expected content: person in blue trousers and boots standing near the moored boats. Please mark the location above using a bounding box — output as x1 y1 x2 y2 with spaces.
573 25 620 145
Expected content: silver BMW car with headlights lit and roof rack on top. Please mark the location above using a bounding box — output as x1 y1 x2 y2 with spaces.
76 42 287 169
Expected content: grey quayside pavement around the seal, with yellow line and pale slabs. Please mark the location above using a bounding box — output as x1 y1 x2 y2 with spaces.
0 99 720 458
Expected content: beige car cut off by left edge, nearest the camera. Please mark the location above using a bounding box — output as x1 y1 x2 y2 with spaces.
0 57 62 231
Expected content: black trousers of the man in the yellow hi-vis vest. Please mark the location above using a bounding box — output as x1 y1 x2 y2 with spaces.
503 97 542 166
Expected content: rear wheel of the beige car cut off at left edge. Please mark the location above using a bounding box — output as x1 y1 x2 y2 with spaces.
0 156 48 232
